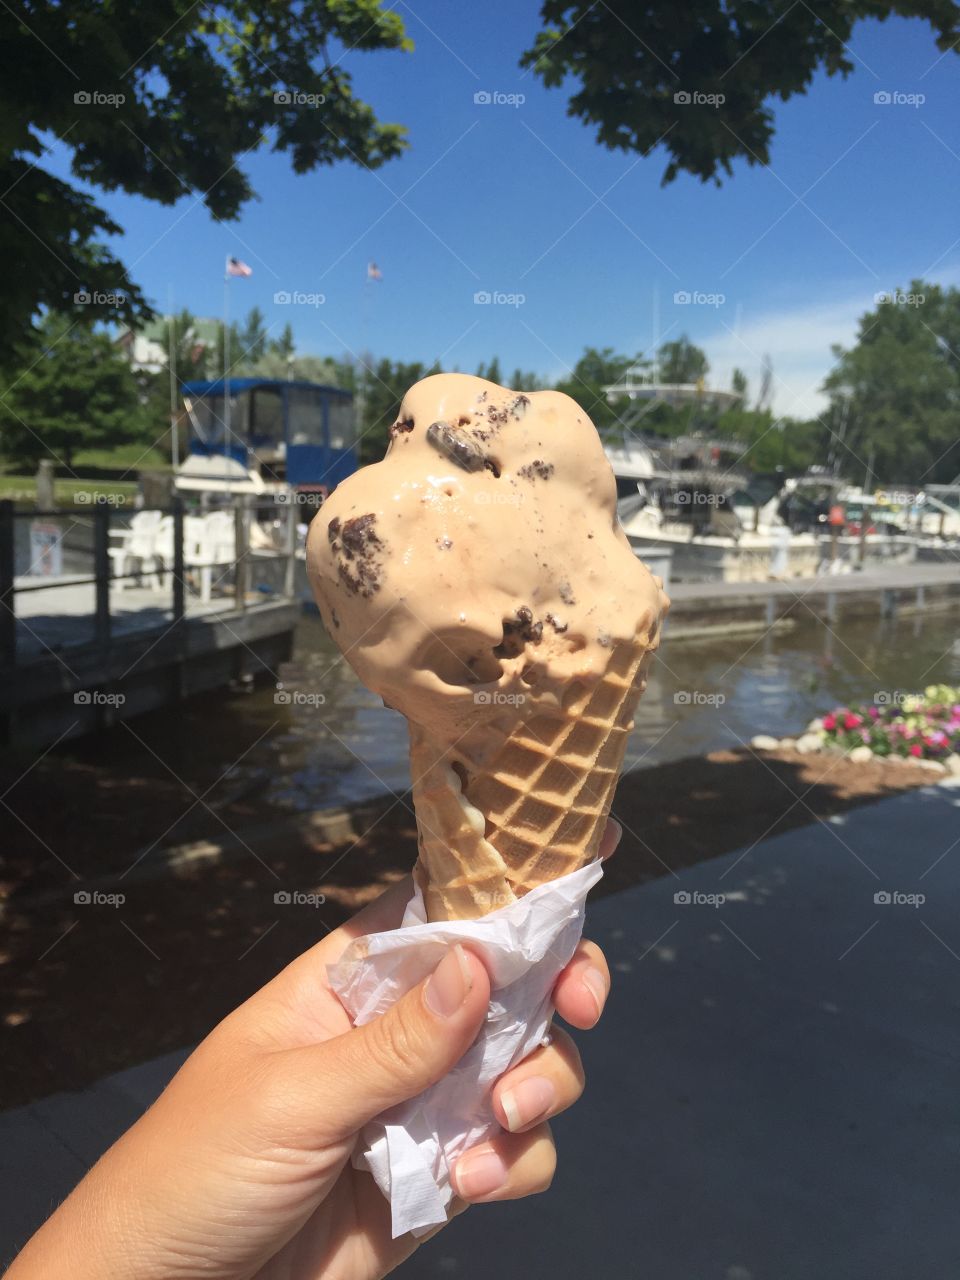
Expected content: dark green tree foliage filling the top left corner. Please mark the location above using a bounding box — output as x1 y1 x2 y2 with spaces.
0 0 412 353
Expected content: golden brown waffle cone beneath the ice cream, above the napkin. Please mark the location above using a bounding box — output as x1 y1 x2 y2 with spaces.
411 636 652 920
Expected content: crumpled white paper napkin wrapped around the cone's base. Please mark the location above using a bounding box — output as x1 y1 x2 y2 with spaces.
329 861 603 1239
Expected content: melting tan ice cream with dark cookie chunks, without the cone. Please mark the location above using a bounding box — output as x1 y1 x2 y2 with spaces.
307 374 666 763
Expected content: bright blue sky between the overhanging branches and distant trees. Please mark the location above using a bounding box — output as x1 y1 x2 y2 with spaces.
43 0 960 416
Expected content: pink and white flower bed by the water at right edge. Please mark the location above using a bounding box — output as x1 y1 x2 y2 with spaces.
809 685 960 763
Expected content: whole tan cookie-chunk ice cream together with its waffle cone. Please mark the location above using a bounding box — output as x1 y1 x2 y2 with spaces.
307 374 668 920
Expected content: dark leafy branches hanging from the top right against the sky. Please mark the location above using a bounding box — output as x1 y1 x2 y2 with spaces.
521 0 960 183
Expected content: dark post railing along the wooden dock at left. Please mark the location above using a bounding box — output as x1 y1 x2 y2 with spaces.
0 495 298 666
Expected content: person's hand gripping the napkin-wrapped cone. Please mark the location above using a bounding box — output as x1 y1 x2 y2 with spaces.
8 823 620 1280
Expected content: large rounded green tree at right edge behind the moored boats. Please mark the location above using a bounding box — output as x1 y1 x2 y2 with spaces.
824 280 960 484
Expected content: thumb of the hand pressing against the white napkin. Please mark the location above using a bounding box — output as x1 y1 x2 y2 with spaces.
275 945 490 1143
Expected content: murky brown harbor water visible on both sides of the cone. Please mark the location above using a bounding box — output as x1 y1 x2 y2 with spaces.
61 611 960 812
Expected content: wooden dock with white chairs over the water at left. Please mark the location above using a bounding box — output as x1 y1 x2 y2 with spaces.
0 503 301 746
